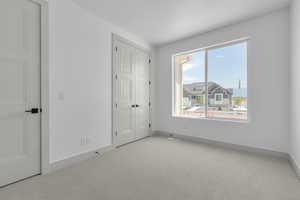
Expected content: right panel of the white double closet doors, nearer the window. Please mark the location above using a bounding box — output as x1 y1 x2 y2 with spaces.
134 49 150 139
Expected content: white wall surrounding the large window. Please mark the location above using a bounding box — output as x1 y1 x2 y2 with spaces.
154 9 290 152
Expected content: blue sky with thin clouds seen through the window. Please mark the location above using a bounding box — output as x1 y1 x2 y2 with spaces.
183 43 247 89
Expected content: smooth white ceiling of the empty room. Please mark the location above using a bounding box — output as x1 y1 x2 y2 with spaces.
73 0 289 46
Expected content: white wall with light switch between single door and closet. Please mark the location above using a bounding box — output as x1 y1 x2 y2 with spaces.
48 0 150 163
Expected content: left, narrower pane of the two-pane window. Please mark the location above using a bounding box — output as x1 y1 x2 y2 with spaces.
175 51 205 117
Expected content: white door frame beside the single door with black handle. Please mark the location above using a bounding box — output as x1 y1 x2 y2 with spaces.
30 0 50 175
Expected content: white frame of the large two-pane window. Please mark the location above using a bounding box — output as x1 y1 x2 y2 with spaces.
171 37 251 123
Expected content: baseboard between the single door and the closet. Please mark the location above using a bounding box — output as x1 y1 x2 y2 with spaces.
50 145 114 173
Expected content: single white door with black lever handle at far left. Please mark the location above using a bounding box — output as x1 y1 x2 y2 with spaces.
0 0 40 186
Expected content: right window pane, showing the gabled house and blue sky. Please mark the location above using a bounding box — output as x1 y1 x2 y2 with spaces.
207 42 248 120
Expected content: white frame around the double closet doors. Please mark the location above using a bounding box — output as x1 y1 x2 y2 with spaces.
111 33 152 148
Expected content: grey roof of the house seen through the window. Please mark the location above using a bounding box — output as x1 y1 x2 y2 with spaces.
183 82 233 96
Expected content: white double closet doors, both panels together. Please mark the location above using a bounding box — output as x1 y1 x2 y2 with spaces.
113 40 149 146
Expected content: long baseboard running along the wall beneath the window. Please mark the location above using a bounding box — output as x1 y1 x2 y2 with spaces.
154 131 289 159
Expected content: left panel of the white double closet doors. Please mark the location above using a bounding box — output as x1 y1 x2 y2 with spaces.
114 41 135 145
